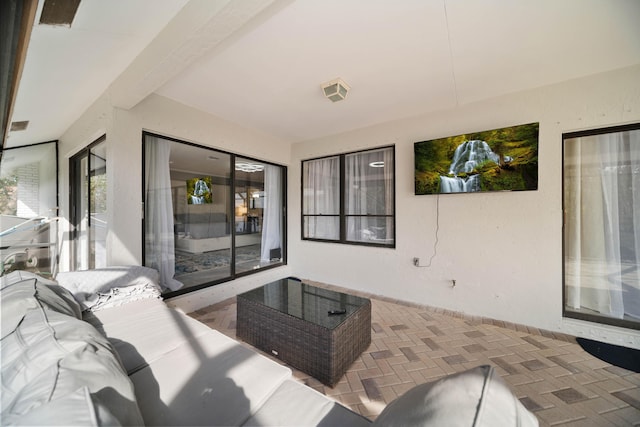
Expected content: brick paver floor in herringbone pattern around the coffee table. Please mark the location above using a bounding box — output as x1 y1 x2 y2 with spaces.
191 283 640 426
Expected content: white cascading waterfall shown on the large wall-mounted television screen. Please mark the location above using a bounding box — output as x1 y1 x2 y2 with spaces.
440 140 511 193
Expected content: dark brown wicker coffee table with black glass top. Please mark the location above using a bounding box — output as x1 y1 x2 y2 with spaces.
237 278 371 387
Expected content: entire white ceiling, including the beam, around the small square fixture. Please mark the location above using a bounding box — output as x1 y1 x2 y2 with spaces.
7 0 640 146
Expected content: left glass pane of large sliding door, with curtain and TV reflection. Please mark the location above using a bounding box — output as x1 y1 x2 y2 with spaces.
145 139 231 292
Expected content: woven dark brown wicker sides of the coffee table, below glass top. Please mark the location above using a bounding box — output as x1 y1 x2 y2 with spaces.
237 295 371 387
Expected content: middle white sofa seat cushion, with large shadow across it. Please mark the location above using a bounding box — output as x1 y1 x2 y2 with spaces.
131 330 291 426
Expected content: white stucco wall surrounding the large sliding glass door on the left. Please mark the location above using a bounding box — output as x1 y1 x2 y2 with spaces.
60 95 291 312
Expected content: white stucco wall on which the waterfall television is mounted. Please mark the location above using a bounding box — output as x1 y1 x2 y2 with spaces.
288 67 640 348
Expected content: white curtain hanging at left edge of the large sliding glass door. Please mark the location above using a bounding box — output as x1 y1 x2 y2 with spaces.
145 136 182 291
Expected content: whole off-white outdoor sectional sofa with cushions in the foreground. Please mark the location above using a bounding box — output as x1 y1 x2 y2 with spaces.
0 266 537 426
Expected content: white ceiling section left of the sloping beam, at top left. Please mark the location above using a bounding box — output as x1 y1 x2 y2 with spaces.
7 0 187 147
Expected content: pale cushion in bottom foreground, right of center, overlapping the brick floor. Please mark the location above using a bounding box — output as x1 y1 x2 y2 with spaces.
374 365 538 427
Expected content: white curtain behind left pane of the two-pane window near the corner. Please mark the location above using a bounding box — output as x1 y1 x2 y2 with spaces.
302 157 340 240
